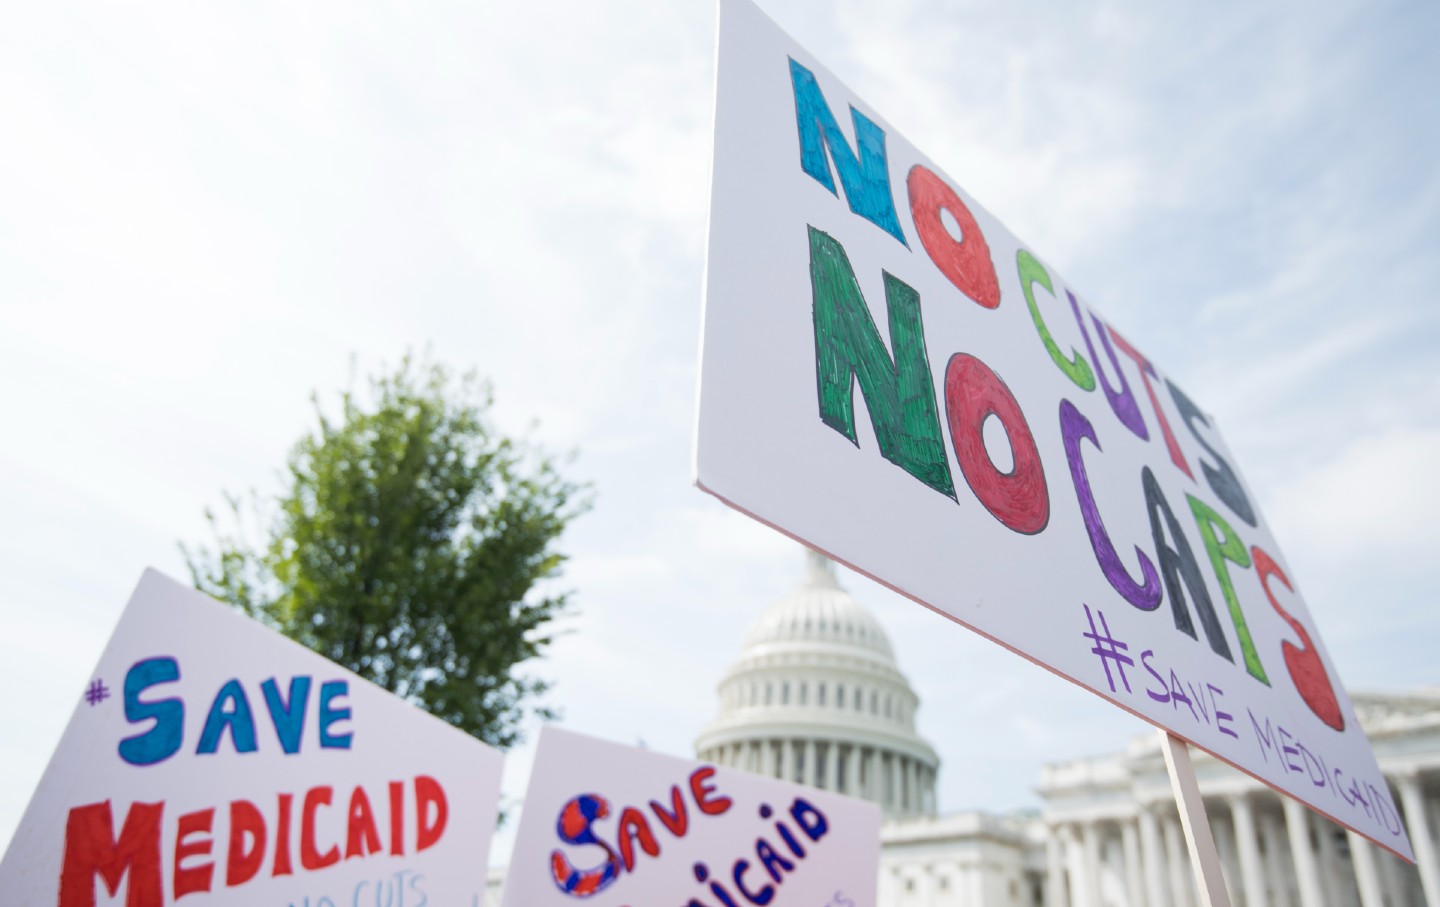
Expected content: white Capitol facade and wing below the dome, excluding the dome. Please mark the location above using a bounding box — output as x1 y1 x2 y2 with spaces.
846 690 1440 907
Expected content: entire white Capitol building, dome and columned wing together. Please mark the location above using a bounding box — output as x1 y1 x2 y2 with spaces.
696 553 1440 907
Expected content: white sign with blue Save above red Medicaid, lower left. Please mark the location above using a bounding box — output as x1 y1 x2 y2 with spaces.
0 570 501 907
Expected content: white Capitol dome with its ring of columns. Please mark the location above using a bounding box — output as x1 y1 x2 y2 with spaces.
696 551 940 819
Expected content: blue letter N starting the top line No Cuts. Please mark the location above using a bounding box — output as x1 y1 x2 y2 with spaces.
791 59 910 248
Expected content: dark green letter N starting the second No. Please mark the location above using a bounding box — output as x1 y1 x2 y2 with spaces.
809 227 955 498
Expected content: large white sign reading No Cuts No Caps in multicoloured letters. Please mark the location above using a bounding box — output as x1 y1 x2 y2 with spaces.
696 0 1410 857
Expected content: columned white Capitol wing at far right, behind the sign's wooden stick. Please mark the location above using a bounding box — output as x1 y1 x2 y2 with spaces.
1040 690 1440 907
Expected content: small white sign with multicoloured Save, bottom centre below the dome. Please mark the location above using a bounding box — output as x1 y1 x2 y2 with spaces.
503 727 880 907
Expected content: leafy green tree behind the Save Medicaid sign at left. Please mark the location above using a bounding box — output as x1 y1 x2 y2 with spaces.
181 357 589 747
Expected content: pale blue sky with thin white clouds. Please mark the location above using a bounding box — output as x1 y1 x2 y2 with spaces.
0 0 1440 857
